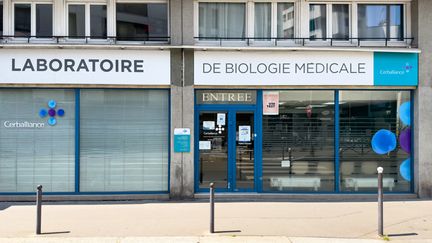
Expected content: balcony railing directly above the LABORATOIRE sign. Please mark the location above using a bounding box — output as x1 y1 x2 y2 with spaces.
0 35 171 45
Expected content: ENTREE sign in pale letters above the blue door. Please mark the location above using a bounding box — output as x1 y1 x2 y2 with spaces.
196 90 256 105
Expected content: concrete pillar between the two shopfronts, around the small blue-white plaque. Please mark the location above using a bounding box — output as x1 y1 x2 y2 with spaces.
170 0 194 199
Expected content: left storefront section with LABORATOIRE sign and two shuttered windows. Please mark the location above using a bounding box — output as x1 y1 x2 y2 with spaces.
0 49 170 195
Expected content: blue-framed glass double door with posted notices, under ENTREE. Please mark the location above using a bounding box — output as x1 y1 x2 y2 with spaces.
197 110 255 191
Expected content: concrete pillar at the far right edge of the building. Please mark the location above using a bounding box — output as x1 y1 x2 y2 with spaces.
412 0 432 198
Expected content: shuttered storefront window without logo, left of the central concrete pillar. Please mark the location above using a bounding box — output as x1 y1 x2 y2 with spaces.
80 90 169 192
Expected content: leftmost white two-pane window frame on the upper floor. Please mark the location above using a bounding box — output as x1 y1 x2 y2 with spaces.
10 0 56 41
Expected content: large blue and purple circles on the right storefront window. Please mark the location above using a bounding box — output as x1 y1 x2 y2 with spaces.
371 102 411 181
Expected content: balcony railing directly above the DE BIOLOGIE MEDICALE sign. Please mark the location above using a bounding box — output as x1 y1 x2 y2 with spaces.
194 36 414 47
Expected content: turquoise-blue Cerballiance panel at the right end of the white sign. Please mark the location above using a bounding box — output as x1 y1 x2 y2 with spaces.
374 52 418 86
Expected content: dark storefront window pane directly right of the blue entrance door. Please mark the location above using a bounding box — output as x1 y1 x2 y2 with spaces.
263 91 335 192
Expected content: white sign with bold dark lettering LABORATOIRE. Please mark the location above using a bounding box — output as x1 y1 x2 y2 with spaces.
0 49 171 85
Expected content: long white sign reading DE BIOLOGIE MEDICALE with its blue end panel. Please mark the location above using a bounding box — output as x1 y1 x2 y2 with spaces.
194 51 418 86
